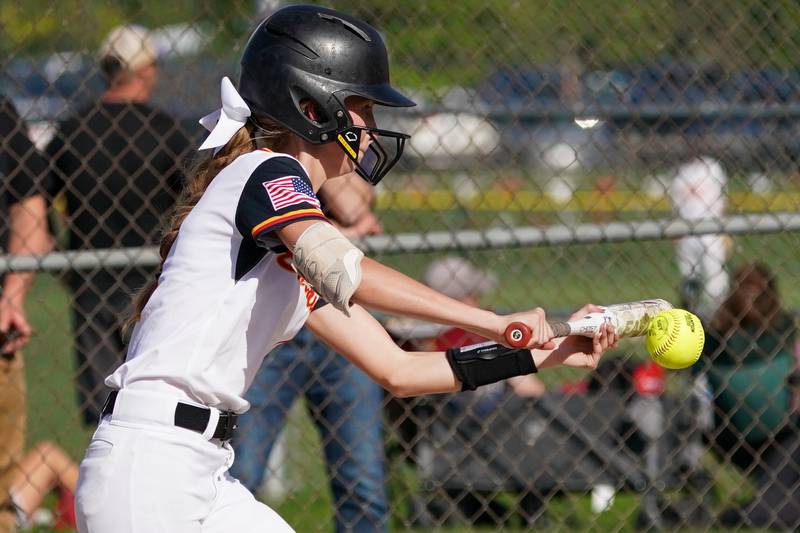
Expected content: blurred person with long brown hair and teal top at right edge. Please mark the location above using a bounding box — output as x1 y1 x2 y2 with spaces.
695 263 800 530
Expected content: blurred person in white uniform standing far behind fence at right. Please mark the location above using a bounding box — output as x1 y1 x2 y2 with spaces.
669 139 730 319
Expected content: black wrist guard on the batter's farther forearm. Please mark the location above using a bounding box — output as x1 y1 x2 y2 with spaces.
447 342 537 390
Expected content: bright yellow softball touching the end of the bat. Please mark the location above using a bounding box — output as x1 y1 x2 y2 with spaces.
646 309 706 370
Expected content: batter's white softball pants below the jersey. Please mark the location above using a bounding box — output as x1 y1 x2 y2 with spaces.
75 390 294 533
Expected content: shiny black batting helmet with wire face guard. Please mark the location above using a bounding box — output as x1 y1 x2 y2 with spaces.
239 5 415 184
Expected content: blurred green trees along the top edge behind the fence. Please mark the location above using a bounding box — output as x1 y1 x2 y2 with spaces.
0 0 800 89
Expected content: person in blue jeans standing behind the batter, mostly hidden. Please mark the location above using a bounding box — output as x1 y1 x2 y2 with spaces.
231 174 389 533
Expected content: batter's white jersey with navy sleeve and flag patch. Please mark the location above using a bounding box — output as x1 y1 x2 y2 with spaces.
106 150 325 412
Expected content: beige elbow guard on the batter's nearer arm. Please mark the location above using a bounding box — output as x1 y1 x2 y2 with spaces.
292 222 364 316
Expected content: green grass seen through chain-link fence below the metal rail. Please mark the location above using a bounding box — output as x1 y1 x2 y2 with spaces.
17 225 800 533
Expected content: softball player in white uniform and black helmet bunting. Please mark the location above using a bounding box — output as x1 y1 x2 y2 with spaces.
76 5 616 533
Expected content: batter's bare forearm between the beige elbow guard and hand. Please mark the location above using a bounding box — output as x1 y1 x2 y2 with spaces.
353 257 506 338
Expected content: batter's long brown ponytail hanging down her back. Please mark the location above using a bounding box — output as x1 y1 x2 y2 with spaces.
125 117 288 328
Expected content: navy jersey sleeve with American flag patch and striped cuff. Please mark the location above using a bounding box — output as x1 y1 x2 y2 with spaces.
236 156 326 250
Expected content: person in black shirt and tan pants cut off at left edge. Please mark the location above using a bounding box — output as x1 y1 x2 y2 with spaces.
0 97 51 533
